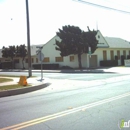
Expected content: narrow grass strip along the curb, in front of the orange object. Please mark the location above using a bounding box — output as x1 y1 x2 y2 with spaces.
0 84 31 91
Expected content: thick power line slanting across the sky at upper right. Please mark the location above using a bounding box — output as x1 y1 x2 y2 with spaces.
73 0 130 14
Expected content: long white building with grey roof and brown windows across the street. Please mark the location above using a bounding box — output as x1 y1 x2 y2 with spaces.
0 31 130 69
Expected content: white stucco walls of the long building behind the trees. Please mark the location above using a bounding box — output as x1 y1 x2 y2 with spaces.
0 31 130 69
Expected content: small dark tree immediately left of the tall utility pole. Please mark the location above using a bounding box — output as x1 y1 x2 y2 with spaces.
16 45 27 69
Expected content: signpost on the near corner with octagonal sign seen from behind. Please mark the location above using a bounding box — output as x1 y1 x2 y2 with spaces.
37 46 44 81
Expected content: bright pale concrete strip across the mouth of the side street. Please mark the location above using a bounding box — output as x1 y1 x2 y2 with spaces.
37 75 130 92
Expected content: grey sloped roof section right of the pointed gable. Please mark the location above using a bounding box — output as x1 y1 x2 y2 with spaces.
105 37 130 48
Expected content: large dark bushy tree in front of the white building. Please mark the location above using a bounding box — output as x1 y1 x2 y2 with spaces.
55 25 98 69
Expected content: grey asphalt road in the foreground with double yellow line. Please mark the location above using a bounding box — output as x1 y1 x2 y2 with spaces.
0 78 130 130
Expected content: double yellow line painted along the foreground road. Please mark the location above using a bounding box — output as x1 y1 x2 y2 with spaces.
0 92 130 130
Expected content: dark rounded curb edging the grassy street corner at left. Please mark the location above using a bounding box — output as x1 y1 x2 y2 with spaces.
0 83 51 97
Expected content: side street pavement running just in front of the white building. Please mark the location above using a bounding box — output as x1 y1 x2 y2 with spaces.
0 72 127 81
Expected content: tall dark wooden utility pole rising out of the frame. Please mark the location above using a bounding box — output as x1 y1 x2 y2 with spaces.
26 0 32 77
